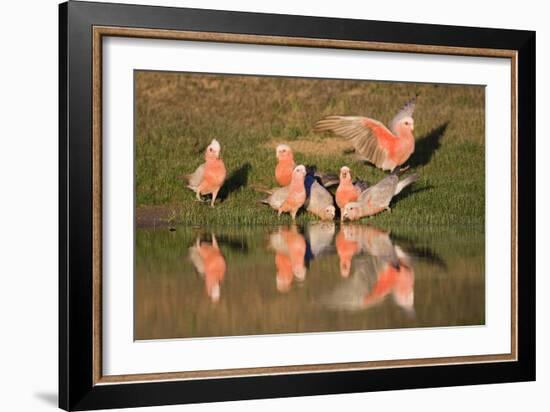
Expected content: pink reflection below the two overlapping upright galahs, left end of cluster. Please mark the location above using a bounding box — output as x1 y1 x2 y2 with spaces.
269 225 307 292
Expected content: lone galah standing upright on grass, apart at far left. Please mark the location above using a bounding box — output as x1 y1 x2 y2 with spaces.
185 139 227 207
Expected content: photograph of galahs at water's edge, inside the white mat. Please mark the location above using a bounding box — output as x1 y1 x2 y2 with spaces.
133 69 486 340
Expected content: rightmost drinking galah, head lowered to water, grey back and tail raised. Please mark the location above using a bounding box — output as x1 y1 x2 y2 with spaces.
342 171 419 220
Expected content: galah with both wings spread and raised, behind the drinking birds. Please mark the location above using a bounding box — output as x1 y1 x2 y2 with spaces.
315 97 416 171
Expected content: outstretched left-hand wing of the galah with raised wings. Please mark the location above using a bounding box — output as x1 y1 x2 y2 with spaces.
315 116 396 168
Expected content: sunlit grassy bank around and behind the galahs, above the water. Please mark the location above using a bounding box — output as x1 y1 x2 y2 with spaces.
135 72 485 231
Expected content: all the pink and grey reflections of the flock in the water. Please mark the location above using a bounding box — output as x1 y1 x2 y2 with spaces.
189 222 445 317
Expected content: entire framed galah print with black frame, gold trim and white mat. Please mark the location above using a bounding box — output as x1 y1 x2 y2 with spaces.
59 1 535 410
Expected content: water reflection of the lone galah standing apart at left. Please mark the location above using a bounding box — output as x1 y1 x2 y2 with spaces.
189 234 226 302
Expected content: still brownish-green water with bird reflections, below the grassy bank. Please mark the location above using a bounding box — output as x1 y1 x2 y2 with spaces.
134 222 485 340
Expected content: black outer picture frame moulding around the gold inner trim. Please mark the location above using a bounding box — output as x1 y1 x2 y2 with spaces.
59 1 535 410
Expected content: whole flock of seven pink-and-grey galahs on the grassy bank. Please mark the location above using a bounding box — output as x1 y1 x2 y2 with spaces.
186 97 418 220
